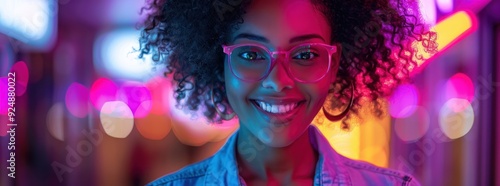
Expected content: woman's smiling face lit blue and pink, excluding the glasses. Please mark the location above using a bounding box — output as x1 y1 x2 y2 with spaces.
224 0 338 147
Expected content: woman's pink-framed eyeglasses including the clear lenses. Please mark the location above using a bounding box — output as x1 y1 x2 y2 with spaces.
222 43 337 83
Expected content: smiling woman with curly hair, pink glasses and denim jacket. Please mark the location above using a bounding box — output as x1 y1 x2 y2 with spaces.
140 0 435 185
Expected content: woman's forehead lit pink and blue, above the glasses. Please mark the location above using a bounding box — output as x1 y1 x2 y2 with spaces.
231 0 331 45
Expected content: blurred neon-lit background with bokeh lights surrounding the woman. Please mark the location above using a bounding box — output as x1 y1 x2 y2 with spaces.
0 0 500 185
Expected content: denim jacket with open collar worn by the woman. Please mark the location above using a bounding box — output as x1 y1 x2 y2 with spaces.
148 125 420 186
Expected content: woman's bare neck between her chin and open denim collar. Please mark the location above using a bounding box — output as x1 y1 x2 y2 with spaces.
236 128 318 185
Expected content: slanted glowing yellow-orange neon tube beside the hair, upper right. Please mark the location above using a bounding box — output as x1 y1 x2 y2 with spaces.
413 11 478 73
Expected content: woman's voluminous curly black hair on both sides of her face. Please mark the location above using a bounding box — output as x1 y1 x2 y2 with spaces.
139 0 437 128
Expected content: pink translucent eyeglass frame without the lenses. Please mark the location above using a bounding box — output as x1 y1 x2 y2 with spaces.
222 43 337 83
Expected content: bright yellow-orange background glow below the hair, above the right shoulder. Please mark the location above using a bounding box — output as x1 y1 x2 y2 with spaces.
312 99 391 167
